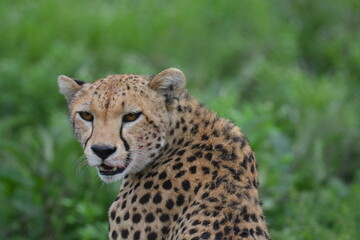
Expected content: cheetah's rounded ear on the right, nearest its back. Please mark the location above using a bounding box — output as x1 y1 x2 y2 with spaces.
149 68 186 111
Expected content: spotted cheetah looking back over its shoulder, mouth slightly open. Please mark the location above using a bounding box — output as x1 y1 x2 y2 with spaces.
58 68 270 240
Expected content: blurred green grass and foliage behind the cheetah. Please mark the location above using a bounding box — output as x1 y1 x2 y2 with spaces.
0 0 360 240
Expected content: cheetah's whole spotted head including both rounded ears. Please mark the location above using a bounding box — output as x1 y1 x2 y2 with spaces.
58 69 185 182
